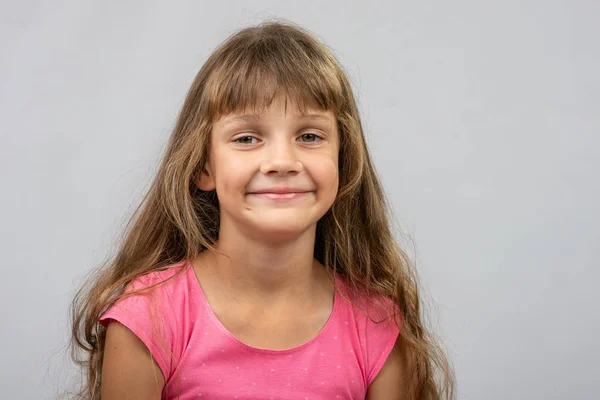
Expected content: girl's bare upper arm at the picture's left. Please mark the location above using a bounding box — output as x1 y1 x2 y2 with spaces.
101 321 165 400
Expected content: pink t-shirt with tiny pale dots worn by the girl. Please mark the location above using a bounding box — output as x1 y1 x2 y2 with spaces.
100 262 399 400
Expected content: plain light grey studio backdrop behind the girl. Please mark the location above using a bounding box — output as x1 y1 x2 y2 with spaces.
0 0 600 400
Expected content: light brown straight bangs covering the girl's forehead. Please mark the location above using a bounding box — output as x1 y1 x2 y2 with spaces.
202 27 345 122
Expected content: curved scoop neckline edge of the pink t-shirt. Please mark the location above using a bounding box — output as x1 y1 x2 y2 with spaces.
184 261 341 355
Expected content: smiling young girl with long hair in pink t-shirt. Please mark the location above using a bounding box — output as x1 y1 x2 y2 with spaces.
73 22 453 400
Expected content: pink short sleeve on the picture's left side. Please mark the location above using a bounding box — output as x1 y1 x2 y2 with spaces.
99 274 177 381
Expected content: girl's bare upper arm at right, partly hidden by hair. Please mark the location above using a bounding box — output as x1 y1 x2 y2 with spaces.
366 337 407 400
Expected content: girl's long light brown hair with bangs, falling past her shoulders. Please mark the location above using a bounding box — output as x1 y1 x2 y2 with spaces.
71 21 454 400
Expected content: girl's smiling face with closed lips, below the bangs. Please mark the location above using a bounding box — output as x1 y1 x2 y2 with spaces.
198 96 339 240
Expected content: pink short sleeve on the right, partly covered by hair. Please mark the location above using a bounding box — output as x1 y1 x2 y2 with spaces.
363 298 400 386
